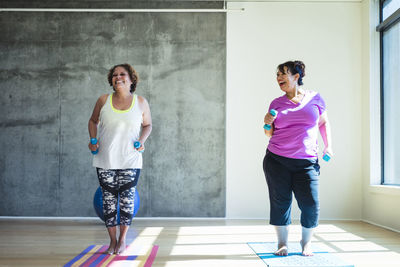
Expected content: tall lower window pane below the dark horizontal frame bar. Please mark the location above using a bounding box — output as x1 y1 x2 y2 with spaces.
383 23 400 185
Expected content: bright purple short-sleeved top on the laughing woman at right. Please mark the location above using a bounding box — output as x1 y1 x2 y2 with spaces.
268 90 326 159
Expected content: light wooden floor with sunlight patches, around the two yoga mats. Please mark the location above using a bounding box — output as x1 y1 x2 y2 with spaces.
0 217 400 267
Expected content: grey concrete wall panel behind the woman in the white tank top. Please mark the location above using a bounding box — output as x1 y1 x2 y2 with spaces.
0 1 226 217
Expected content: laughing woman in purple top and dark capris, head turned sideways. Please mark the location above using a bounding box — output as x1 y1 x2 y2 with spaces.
263 61 333 256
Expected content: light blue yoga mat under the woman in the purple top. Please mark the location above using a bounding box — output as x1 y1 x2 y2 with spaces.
247 242 354 267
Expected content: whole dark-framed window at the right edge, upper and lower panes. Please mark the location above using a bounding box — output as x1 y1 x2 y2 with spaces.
376 0 400 185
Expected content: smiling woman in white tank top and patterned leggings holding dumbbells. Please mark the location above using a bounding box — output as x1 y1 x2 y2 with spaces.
88 64 152 254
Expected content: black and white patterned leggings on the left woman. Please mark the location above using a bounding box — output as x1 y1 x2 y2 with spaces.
97 168 140 227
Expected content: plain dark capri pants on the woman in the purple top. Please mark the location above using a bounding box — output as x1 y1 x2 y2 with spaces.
263 149 320 228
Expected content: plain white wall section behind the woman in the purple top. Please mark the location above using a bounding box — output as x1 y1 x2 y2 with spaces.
226 2 364 220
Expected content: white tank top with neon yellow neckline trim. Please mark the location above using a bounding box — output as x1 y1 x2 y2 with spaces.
93 94 143 169
